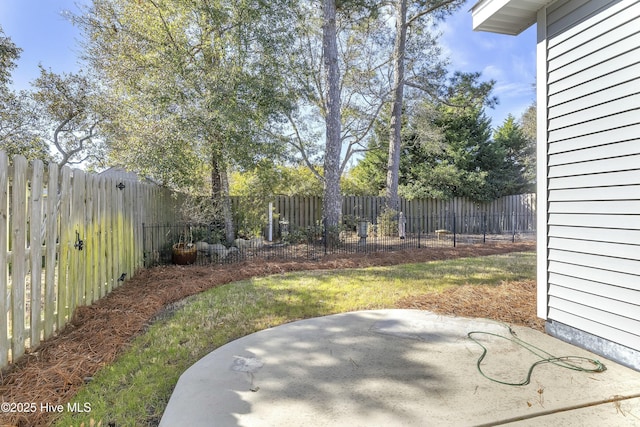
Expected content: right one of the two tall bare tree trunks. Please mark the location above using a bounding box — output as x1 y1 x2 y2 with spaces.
386 0 407 210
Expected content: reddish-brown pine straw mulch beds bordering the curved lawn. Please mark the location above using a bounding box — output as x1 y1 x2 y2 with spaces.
0 242 541 426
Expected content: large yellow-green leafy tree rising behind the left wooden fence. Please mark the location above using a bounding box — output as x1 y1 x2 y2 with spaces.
74 0 290 241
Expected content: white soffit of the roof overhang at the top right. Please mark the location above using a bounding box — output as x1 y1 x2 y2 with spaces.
471 0 553 36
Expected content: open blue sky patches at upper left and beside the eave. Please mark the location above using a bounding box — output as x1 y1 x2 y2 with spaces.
0 0 536 127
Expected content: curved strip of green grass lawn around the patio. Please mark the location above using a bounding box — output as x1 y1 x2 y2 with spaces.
56 252 536 427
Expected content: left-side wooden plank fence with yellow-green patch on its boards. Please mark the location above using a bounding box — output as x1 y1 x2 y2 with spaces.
0 151 175 368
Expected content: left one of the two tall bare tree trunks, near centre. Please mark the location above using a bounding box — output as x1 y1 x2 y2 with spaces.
322 0 342 228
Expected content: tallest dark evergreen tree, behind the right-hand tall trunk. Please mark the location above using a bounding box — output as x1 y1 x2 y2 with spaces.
350 73 499 199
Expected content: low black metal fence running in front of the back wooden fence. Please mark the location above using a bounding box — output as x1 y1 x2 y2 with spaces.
143 213 536 267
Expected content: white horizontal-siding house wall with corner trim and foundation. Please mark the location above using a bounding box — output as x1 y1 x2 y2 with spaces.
538 0 640 369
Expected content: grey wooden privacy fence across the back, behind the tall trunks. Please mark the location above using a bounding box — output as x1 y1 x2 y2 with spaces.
238 194 536 233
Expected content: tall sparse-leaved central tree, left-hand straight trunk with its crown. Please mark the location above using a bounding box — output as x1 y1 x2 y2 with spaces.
280 0 388 231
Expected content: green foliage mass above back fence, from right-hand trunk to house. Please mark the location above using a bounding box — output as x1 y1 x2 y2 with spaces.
350 75 531 201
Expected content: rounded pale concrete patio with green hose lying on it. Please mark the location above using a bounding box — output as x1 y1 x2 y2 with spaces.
160 310 640 427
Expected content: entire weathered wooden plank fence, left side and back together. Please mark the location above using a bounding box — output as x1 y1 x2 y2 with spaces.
0 146 535 368
